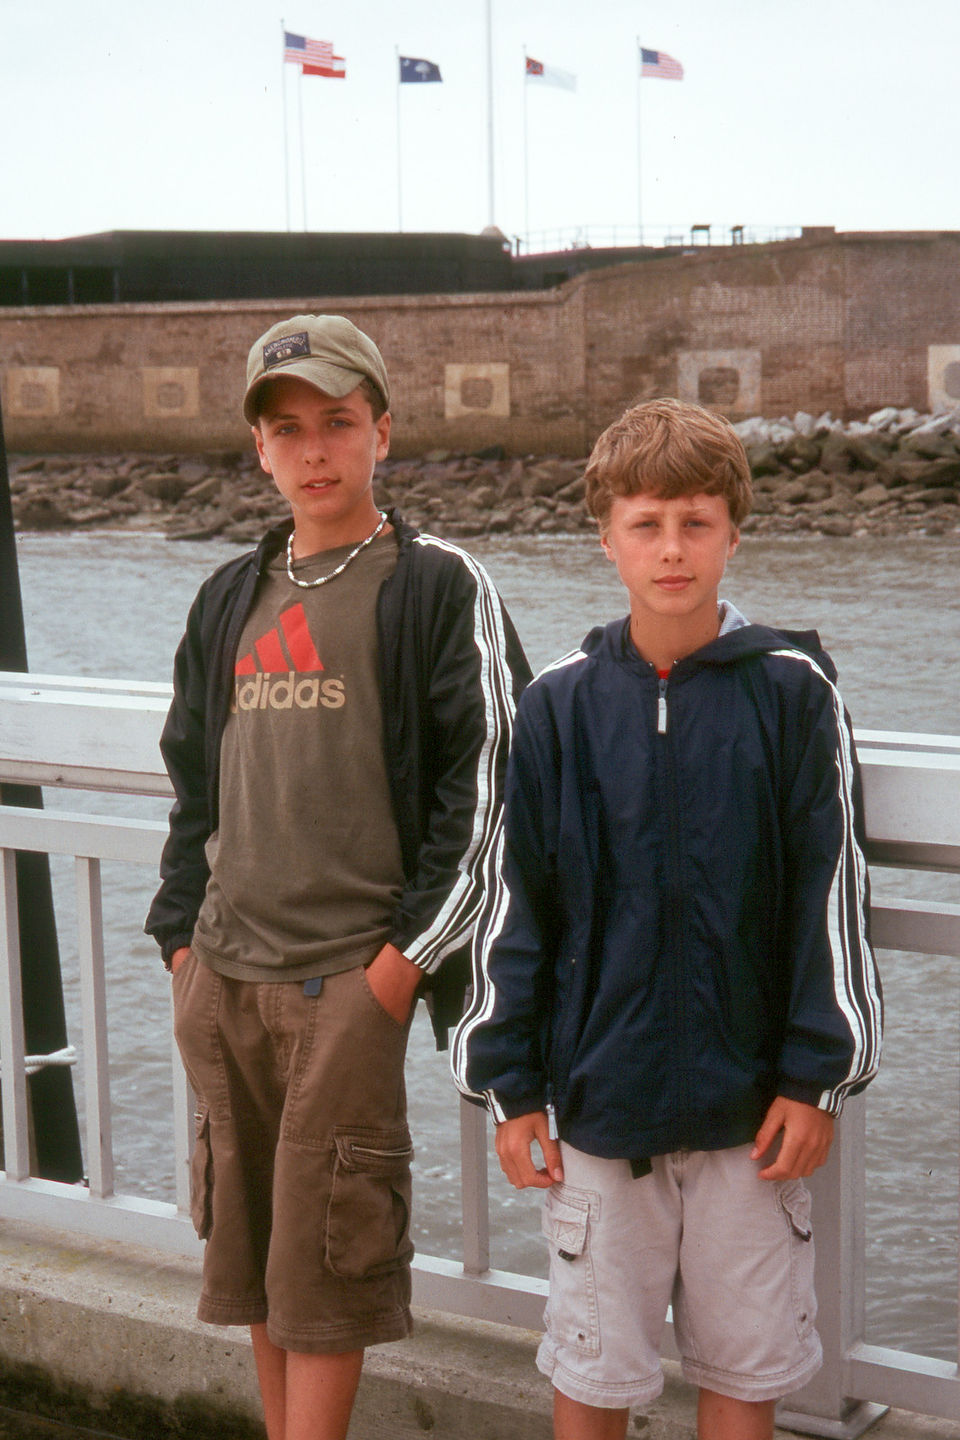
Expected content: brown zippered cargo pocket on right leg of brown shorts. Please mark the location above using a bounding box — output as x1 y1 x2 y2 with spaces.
327 1125 413 1280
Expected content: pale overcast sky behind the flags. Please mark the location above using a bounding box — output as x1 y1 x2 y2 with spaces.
0 0 960 249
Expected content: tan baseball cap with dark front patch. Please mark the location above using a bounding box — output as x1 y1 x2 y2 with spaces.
243 315 390 425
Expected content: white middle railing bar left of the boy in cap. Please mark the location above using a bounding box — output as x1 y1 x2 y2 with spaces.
0 805 167 865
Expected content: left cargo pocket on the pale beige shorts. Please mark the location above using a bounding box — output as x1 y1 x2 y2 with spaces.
540 1185 600 1355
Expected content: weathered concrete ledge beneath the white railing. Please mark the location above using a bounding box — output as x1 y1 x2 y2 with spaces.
0 1221 957 1440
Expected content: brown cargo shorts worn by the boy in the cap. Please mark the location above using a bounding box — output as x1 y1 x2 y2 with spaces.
173 953 413 1354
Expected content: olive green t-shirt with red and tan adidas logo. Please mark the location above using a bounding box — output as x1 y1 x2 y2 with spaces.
193 531 403 981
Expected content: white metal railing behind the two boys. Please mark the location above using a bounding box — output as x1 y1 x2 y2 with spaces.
0 672 960 1437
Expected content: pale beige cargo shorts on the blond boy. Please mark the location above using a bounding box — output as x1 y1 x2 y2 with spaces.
537 1143 822 1408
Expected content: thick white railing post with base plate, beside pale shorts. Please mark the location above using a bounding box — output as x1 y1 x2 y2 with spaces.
777 1096 887 1440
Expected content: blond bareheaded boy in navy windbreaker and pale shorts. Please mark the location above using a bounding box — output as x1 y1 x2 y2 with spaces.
453 399 881 1440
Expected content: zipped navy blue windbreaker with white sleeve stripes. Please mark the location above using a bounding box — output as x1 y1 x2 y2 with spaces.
452 608 882 1158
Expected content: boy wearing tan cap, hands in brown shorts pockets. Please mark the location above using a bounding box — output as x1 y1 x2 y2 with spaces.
147 315 528 1440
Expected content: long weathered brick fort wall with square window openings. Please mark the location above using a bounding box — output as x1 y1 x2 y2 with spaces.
0 230 960 455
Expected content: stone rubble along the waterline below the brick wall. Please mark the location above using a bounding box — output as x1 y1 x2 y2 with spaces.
9 406 960 544
